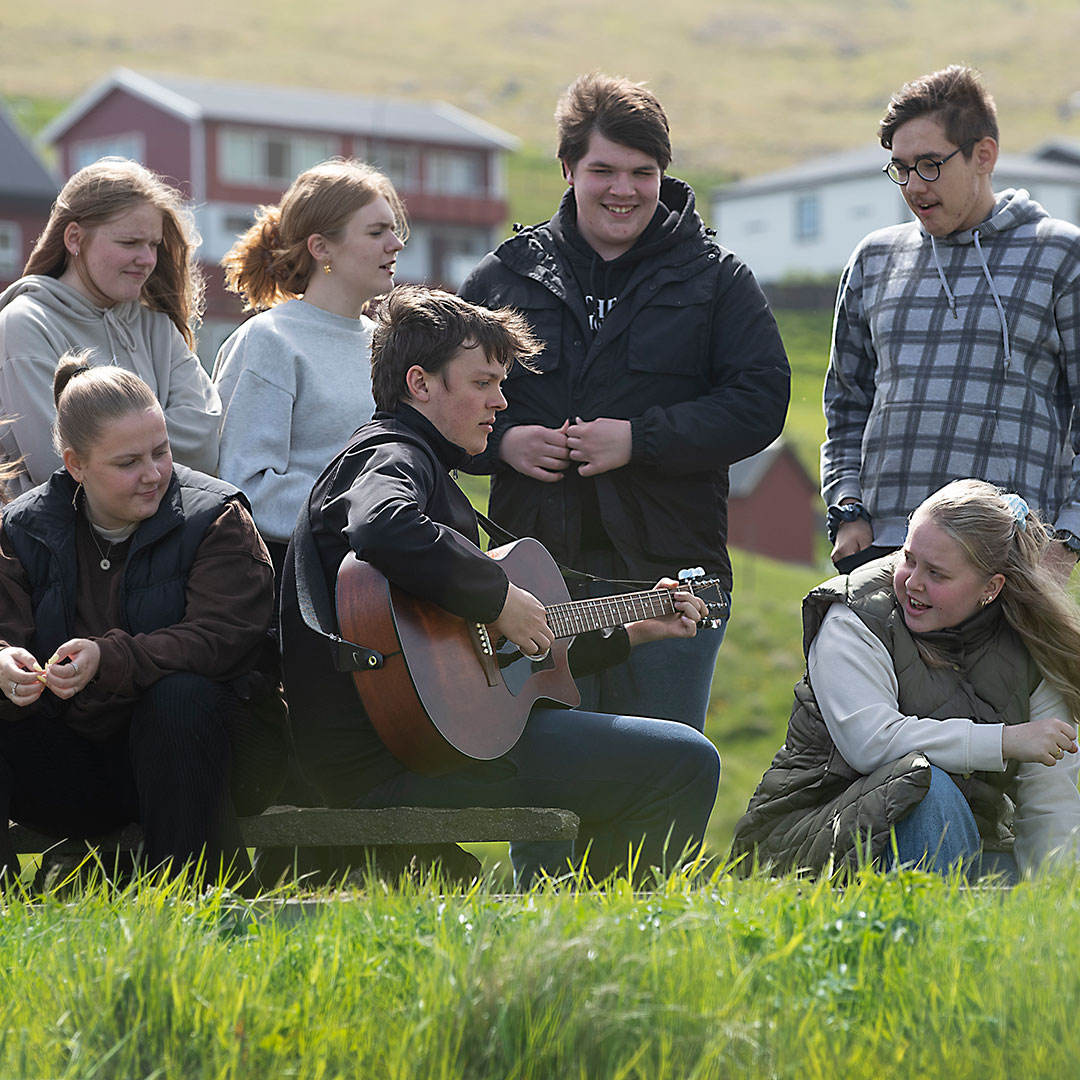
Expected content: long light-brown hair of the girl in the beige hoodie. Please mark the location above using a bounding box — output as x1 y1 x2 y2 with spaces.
23 158 205 349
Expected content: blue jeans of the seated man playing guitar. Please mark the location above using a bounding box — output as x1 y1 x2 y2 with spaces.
354 708 720 887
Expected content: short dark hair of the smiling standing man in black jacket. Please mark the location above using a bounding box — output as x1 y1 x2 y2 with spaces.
555 71 672 173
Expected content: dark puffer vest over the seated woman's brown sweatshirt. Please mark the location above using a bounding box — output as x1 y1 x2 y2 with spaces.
3 464 247 716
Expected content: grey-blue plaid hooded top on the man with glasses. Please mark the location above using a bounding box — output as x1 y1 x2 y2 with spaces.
821 190 1080 546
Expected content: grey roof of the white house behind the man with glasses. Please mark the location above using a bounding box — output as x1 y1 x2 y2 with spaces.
713 140 1080 201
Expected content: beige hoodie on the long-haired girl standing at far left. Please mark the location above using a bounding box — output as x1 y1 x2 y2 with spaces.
0 274 221 495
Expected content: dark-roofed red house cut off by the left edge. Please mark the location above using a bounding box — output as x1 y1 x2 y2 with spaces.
0 105 59 289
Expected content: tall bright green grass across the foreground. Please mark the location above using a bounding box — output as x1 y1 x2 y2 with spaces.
0 873 1080 1080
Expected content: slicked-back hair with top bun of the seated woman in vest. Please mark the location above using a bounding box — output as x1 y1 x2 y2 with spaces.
53 349 161 457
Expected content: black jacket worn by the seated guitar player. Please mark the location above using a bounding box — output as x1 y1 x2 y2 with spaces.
281 405 629 806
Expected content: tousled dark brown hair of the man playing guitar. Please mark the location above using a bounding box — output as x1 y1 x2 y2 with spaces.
372 285 543 413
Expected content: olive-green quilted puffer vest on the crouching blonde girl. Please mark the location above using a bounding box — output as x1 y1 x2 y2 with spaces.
732 555 1041 873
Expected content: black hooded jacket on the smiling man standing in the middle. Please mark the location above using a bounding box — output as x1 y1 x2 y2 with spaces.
461 177 789 588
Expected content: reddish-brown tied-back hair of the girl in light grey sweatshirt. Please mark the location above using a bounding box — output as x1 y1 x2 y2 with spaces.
221 158 408 311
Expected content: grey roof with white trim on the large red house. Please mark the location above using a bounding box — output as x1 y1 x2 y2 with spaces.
42 68 518 150
